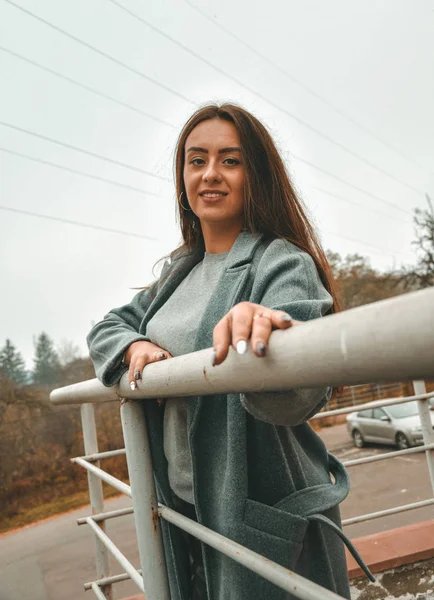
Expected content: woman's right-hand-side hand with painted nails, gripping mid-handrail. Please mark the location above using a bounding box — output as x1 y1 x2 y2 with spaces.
213 302 300 366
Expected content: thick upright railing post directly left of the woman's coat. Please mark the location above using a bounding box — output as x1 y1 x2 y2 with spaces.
121 400 170 600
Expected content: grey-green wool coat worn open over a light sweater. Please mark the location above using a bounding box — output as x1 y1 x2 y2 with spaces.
88 232 366 600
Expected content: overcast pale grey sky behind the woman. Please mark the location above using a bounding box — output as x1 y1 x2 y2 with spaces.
0 0 434 367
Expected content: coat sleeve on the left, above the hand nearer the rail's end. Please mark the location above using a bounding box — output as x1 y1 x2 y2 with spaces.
87 263 168 386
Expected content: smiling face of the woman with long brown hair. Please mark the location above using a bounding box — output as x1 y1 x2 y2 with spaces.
181 119 245 228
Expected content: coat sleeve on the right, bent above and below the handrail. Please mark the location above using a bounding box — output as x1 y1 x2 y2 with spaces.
241 240 333 426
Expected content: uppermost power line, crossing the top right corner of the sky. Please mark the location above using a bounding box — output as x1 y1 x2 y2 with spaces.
184 0 433 174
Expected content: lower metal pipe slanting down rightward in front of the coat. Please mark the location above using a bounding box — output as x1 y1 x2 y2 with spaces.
159 505 342 600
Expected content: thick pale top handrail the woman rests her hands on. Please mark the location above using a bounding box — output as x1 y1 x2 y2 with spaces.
50 289 434 404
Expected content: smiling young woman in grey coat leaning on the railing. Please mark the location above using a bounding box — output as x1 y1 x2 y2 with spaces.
88 104 372 600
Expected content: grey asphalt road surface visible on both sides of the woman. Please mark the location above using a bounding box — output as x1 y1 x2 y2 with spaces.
0 425 434 600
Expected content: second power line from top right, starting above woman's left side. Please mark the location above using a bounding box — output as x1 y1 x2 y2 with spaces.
107 0 424 194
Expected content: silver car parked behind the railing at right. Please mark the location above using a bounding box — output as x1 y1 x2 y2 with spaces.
347 400 434 450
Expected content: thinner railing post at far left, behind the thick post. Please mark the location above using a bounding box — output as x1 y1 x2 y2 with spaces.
81 404 113 600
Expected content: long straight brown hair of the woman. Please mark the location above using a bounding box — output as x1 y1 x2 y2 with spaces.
174 104 340 312
